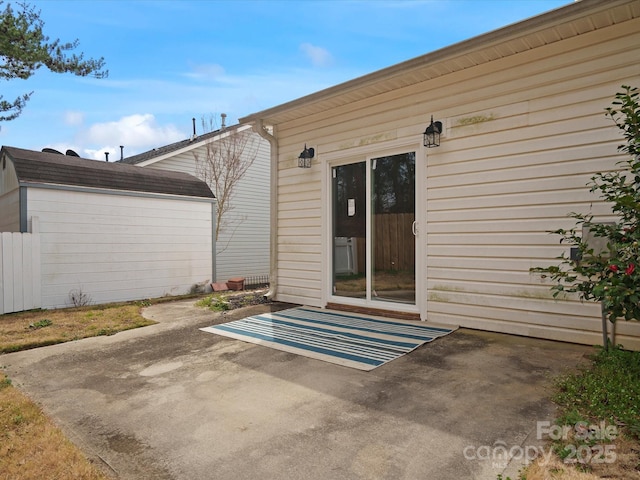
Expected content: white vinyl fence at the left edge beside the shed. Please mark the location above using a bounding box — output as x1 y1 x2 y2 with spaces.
0 232 42 314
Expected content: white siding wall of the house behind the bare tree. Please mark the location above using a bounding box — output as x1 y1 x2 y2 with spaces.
147 134 270 282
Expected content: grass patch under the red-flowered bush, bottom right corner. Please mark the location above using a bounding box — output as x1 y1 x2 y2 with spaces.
522 347 640 480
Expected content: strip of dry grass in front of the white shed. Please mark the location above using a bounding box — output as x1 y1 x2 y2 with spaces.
0 302 155 353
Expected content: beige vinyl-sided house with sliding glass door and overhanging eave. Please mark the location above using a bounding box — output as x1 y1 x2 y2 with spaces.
240 0 640 348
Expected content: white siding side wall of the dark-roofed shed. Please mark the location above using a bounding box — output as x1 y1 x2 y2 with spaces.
28 188 213 308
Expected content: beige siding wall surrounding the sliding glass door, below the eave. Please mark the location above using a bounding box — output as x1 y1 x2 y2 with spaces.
278 16 640 348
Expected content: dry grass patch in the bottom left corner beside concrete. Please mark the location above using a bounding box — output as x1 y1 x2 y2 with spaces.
0 373 109 480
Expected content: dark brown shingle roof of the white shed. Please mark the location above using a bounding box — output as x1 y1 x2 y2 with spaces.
0 146 215 198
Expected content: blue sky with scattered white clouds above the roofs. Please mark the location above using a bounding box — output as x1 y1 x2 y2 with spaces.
0 0 571 160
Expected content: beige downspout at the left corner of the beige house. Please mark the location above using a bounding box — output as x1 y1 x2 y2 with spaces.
253 119 278 299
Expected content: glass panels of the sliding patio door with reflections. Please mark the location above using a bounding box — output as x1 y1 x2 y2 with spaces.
332 152 415 304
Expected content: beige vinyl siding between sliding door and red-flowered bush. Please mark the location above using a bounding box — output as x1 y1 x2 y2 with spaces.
426 21 640 348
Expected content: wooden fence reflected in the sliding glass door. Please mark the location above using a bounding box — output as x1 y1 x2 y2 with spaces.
355 213 416 273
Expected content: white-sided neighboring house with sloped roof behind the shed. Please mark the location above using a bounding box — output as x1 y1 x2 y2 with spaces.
121 125 270 282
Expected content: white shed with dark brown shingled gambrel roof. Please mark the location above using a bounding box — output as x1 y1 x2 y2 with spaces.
0 146 215 313
